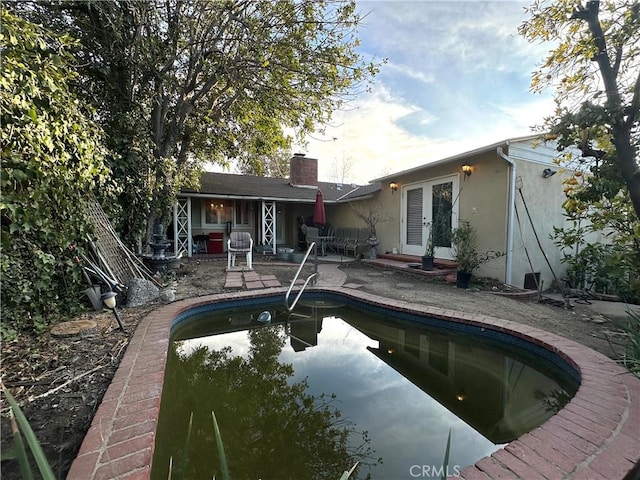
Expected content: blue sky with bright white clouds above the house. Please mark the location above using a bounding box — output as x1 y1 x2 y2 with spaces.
294 0 554 184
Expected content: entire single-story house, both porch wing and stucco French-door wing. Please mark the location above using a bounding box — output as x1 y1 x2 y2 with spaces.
174 135 584 287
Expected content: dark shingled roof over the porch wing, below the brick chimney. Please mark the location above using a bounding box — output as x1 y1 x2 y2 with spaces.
182 172 380 203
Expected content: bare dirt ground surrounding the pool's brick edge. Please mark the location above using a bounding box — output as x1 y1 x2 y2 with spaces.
0 259 632 480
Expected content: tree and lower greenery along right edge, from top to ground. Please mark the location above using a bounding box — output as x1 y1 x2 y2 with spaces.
520 0 640 301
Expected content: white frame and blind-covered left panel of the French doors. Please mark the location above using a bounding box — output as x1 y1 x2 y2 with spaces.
400 174 460 259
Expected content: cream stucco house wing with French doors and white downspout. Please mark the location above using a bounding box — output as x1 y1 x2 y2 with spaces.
375 136 592 288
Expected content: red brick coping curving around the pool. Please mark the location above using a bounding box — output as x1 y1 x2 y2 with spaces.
67 287 640 480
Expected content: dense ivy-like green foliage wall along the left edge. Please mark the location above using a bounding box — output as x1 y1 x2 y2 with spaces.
0 7 115 330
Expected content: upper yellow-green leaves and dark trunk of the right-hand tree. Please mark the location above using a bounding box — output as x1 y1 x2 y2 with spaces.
520 0 640 219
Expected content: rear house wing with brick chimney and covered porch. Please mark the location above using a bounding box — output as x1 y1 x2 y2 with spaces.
173 154 380 256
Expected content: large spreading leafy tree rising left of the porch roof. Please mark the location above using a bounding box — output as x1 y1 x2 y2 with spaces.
18 0 377 248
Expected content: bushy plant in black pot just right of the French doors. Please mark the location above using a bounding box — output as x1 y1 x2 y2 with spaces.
451 221 504 288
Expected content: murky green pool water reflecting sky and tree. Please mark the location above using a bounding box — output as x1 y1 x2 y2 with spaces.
152 307 577 480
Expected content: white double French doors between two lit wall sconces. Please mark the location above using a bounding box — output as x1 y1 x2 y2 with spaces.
401 175 459 259
